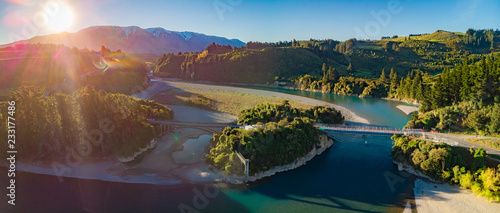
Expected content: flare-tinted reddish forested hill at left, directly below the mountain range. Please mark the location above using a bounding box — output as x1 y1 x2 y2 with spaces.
0 44 147 94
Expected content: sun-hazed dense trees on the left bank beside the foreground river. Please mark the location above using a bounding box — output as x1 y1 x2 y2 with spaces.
0 86 173 162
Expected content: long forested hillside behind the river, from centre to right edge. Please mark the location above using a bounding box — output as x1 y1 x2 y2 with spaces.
155 29 500 85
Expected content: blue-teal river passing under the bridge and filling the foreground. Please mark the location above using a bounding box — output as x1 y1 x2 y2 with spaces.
0 87 415 212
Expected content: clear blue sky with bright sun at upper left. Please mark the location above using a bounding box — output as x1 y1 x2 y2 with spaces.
0 0 500 44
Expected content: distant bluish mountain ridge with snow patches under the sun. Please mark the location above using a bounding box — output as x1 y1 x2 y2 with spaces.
0 26 245 54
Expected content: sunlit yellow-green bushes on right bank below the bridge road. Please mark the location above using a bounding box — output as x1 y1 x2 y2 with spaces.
392 134 500 201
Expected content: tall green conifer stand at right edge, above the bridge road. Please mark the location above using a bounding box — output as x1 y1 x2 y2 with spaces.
407 57 500 134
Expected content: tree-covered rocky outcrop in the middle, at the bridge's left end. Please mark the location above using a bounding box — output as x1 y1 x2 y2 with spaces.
206 101 343 175
